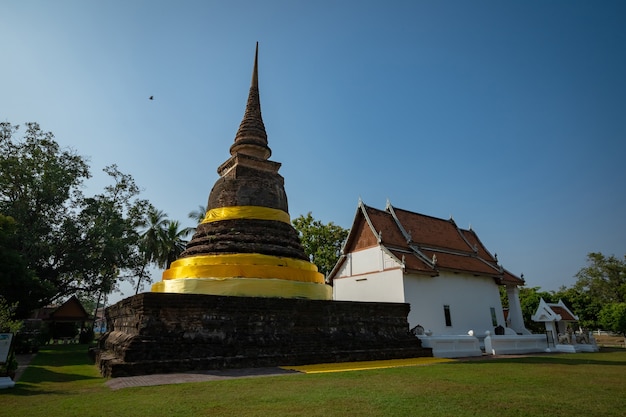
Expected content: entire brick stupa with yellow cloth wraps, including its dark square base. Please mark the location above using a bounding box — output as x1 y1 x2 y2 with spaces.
95 44 432 377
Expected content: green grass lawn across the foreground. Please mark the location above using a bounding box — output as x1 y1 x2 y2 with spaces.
0 345 626 417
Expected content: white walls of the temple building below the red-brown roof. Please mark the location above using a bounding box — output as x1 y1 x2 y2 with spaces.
333 247 506 338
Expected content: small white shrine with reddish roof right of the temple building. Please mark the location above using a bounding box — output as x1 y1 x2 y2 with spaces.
532 298 599 353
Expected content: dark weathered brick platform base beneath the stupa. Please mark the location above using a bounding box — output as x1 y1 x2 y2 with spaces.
97 293 432 377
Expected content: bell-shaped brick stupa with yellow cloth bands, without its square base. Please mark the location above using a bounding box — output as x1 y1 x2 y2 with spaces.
152 43 332 300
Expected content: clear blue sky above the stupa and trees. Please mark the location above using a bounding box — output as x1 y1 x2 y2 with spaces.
0 0 626 304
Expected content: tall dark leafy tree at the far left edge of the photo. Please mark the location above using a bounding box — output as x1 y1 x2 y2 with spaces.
0 123 90 317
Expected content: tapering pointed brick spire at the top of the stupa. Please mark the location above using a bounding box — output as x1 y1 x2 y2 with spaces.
230 42 272 160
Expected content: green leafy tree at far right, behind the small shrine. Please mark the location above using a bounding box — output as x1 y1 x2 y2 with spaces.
574 252 626 304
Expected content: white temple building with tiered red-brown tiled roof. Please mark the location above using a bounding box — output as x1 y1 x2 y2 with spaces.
328 201 530 356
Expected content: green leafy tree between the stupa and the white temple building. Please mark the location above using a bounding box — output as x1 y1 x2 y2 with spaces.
292 212 348 276
